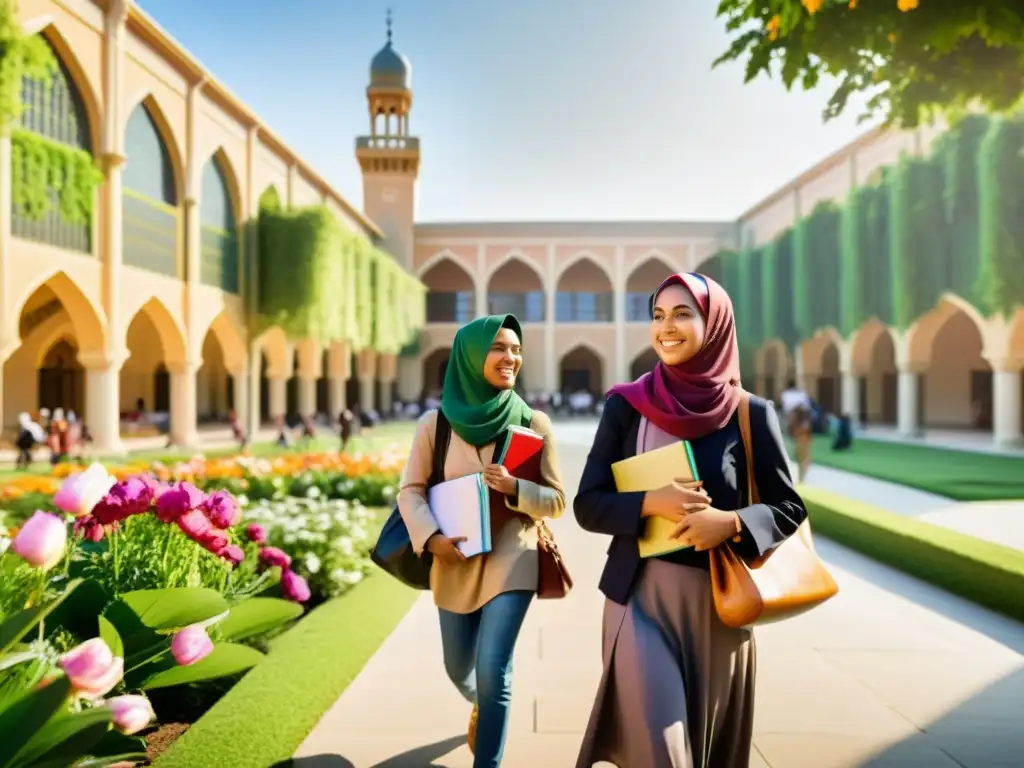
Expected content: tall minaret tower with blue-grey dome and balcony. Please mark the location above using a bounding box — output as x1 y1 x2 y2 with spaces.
355 10 420 270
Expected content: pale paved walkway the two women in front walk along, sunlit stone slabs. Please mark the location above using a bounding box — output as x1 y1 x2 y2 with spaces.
294 425 1024 768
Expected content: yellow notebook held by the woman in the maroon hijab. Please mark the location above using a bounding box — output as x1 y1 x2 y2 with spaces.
611 440 700 557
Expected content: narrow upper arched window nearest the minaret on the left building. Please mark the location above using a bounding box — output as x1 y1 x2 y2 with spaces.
200 155 241 293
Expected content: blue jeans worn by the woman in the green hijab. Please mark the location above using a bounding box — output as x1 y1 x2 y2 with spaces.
439 591 534 768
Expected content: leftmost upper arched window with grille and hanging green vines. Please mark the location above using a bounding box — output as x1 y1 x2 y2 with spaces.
10 37 92 253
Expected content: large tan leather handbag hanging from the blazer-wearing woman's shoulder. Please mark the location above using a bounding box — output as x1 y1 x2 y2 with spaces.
711 392 839 628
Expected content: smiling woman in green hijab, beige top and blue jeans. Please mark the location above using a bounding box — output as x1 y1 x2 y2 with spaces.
398 314 565 768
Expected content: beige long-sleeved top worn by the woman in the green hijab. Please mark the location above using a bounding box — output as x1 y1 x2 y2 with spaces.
398 411 565 613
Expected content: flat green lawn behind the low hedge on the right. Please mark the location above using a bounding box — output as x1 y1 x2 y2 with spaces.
791 436 1024 502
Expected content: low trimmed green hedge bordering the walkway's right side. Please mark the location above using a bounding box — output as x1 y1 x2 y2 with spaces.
800 487 1024 622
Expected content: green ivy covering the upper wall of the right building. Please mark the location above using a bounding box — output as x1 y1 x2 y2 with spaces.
700 115 1024 366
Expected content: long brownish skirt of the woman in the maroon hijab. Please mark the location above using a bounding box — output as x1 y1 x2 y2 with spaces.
577 560 756 768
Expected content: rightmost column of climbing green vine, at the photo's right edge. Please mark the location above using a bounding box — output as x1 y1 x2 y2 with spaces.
978 116 1024 314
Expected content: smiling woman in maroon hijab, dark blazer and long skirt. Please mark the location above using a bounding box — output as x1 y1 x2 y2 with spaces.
573 273 807 768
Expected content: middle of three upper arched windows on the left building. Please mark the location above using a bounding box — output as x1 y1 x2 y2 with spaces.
122 101 184 278
